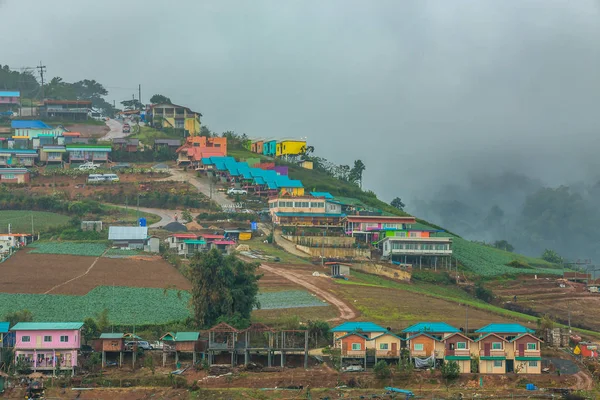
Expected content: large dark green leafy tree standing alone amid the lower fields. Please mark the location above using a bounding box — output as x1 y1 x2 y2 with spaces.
190 249 261 327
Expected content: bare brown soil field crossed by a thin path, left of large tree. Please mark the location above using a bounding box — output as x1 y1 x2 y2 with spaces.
0 251 191 295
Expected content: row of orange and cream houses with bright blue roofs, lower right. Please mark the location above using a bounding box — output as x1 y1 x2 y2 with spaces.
331 322 542 374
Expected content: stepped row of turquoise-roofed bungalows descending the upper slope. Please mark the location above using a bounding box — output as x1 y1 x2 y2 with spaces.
199 157 304 196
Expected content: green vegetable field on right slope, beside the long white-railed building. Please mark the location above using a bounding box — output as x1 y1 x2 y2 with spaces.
452 237 562 277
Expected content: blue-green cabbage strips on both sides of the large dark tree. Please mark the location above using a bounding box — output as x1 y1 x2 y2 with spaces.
0 286 328 325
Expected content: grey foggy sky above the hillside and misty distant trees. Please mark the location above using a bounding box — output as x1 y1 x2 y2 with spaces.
0 0 600 205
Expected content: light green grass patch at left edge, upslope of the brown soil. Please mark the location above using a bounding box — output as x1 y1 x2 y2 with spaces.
0 210 70 233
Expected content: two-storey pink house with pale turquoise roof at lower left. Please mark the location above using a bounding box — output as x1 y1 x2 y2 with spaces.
11 322 83 374
